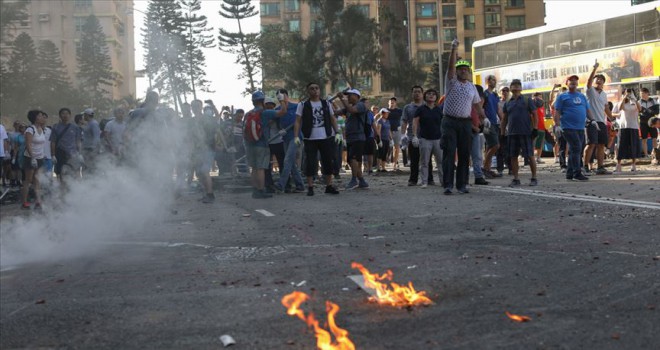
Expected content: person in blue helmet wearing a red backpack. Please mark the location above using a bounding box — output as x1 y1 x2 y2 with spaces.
245 91 289 198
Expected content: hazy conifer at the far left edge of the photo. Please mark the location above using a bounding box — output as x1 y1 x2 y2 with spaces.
2 33 39 116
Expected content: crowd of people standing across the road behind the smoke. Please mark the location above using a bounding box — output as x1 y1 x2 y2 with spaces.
0 41 660 210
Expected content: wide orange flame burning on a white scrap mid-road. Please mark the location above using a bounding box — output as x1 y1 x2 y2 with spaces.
351 262 433 306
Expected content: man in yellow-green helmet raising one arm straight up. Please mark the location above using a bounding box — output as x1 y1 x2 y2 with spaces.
440 39 486 195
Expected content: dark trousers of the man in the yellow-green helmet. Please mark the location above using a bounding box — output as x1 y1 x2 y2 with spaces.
440 116 472 189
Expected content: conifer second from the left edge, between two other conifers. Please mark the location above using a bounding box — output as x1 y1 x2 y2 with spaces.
36 40 72 113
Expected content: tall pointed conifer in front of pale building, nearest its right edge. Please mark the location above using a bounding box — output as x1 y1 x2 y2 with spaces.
76 15 115 109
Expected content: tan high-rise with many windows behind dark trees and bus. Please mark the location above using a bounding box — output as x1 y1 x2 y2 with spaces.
260 0 545 96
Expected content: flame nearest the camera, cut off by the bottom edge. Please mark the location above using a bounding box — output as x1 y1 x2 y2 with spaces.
282 291 355 350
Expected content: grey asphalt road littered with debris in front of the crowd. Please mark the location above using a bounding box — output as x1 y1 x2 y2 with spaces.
0 160 660 349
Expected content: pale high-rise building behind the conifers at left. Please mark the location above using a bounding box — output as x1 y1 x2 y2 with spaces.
2 0 135 99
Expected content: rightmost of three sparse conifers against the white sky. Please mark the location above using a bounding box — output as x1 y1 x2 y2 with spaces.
218 0 261 95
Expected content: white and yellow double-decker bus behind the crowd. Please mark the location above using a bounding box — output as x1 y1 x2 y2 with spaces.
472 1 660 112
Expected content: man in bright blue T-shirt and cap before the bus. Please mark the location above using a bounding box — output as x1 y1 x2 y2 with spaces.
553 75 593 181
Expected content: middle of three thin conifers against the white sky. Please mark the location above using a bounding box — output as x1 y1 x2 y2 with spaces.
181 0 215 99
